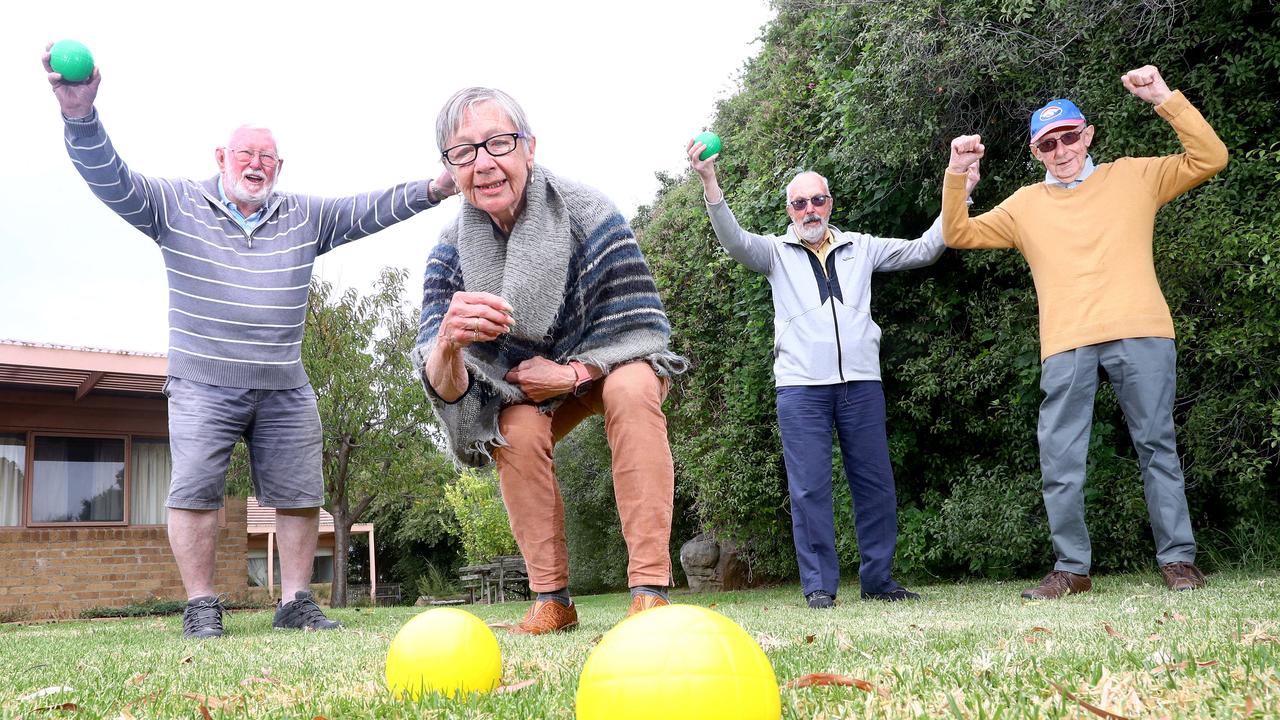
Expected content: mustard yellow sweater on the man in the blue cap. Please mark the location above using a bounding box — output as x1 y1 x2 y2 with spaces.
942 92 1226 360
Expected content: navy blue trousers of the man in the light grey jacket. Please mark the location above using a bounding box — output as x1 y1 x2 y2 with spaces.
777 380 899 596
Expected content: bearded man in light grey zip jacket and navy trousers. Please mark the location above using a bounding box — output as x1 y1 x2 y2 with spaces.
687 141 978 609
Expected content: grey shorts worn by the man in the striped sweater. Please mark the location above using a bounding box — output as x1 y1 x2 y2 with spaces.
165 377 324 510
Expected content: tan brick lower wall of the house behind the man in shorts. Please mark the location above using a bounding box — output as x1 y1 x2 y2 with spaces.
0 497 248 619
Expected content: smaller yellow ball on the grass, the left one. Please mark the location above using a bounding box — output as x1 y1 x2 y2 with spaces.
387 607 502 700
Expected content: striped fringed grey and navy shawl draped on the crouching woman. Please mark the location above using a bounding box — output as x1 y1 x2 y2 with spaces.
412 167 687 466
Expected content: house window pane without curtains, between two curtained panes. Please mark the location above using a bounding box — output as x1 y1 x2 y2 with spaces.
31 436 124 524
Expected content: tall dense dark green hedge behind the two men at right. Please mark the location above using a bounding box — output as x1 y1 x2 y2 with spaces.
635 0 1280 575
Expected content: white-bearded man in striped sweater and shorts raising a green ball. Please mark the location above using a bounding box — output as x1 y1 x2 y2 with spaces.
44 51 456 638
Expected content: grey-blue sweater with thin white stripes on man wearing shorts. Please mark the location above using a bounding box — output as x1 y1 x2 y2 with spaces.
64 110 433 389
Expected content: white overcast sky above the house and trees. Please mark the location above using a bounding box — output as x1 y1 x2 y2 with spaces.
0 0 772 352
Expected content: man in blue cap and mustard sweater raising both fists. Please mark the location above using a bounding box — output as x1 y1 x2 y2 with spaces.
942 65 1226 600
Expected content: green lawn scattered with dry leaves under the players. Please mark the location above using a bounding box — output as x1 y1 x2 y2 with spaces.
0 571 1280 720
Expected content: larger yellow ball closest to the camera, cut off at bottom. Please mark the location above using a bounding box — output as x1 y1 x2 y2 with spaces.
577 605 782 720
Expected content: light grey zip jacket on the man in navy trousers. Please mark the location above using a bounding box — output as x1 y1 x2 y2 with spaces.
707 200 946 387
